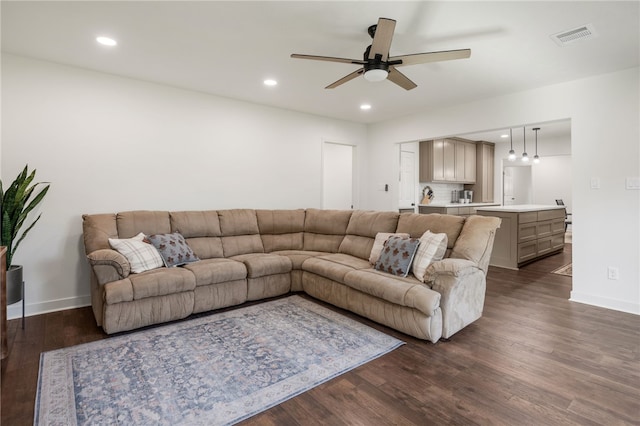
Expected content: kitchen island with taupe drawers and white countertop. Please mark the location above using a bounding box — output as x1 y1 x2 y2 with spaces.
476 204 566 269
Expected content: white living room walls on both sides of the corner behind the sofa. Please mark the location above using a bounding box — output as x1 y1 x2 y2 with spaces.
5 54 640 317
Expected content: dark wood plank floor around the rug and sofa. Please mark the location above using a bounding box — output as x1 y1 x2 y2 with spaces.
1 245 640 426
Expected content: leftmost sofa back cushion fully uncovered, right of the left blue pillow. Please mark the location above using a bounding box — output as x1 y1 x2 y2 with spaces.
218 209 264 257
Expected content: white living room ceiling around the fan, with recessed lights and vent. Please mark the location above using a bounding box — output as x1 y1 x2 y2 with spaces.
1 1 640 123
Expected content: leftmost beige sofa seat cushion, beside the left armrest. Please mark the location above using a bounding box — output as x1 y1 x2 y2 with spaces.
129 268 196 300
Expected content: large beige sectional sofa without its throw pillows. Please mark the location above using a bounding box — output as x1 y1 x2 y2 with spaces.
83 209 500 343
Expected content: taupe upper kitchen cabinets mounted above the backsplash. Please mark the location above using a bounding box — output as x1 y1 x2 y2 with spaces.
420 138 476 183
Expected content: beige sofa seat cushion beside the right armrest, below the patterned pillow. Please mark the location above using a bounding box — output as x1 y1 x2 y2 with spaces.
344 269 440 316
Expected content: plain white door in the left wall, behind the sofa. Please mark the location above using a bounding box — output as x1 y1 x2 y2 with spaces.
322 142 355 210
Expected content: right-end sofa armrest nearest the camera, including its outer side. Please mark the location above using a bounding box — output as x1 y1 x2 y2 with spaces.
425 258 487 338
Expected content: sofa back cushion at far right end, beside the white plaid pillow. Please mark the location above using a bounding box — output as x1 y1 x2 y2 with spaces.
451 216 501 274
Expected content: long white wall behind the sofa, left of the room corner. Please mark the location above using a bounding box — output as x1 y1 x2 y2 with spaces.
0 54 367 318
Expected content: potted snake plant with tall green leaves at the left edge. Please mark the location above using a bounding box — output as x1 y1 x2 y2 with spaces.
0 165 49 305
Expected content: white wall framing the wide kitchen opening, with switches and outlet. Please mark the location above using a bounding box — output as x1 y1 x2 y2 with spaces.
363 68 640 313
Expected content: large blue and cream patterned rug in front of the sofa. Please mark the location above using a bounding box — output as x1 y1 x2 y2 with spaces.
34 296 404 426
